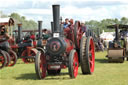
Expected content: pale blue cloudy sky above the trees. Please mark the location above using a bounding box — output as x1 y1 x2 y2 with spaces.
0 0 128 28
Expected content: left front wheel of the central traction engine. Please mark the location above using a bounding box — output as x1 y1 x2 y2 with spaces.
35 51 47 79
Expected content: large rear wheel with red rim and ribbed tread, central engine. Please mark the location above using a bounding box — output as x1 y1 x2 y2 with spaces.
80 36 95 74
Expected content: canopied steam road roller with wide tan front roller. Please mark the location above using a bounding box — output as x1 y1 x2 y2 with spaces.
106 24 128 63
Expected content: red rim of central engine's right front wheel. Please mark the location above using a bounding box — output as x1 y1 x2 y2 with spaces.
73 52 79 78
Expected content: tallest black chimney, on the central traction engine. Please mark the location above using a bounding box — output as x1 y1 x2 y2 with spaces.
52 5 60 32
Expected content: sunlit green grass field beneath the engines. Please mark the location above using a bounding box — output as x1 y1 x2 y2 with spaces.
0 52 128 85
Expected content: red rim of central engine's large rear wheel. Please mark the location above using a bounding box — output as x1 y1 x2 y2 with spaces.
89 39 95 72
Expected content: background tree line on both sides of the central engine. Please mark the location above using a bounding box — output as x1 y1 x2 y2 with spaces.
0 11 128 32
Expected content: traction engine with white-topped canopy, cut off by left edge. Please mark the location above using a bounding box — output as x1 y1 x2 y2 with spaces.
0 18 17 68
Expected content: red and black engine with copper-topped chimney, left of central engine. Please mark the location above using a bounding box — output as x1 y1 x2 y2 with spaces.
11 23 38 63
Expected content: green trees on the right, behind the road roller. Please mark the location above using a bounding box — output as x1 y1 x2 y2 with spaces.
85 17 128 32
